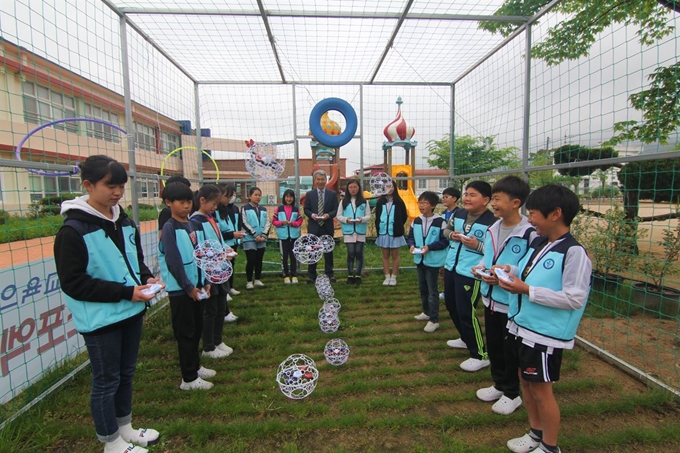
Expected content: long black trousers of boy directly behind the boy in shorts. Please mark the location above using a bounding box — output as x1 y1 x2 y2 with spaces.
484 307 519 400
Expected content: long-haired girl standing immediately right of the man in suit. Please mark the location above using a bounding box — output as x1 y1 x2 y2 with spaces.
336 179 371 286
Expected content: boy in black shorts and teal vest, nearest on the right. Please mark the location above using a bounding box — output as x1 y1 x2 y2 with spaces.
498 184 592 453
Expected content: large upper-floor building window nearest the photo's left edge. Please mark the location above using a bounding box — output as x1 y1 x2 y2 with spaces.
22 82 78 133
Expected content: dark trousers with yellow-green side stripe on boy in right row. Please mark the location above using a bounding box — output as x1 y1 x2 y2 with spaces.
444 270 488 359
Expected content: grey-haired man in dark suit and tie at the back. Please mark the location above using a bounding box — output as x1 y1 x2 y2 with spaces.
304 170 338 284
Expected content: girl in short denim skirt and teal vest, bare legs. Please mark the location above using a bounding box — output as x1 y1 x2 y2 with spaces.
375 185 408 286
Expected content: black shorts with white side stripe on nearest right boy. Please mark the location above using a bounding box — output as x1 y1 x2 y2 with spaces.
510 335 563 382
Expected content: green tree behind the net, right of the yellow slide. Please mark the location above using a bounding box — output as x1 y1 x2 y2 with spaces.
427 134 519 183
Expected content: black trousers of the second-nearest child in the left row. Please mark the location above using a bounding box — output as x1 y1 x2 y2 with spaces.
170 295 205 382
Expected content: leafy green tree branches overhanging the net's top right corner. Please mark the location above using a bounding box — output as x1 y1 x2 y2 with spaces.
479 0 680 145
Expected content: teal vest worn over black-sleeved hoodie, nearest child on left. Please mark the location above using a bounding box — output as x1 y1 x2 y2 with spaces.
64 219 146 333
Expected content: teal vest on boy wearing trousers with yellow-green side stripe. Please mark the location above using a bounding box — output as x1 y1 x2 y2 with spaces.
444 211 496 280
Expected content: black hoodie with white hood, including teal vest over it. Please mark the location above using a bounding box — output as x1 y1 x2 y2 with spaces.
54 195 153 333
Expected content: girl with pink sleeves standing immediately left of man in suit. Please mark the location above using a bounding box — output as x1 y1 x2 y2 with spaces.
272 189 304 285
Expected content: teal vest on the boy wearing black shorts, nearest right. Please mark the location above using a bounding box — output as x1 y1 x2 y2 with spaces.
508 234 586 341
